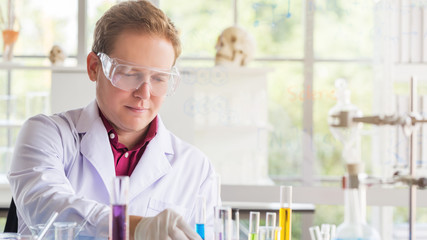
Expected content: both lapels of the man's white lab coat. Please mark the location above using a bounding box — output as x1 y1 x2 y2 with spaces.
76 101 174 201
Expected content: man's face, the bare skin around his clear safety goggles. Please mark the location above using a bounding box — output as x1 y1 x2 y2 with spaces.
96 31 175 134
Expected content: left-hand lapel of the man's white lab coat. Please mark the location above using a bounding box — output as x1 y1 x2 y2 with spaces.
76 101 116 196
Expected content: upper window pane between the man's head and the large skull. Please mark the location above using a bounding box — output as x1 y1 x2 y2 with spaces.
160 0 233 57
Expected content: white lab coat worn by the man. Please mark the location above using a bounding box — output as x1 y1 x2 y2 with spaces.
8 101 218 237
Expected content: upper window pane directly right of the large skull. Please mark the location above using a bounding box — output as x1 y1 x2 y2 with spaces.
238 0 304 58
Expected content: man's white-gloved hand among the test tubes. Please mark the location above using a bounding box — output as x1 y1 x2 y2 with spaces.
134 209 201 240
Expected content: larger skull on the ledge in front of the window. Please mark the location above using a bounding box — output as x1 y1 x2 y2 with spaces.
215 26 255 66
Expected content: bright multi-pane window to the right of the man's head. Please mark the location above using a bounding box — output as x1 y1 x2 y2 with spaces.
160 0 374 184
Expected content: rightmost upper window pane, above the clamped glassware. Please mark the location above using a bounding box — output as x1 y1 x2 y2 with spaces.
309 0 375 58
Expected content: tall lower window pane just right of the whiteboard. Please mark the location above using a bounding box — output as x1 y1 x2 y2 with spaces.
260 62 304 181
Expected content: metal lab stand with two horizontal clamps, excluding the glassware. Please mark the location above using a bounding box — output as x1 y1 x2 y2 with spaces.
328 77 427 240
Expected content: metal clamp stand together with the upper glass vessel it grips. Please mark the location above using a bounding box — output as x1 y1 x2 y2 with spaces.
328 77 427 240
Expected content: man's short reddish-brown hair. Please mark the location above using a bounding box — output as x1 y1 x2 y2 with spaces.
92 0 181 60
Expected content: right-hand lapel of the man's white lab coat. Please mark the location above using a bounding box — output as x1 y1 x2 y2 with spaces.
129 116 173 201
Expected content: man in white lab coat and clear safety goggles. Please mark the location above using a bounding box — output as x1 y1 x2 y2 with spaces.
8 1 218 239
